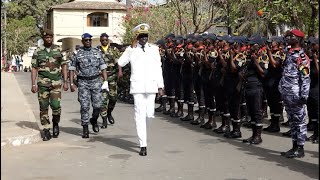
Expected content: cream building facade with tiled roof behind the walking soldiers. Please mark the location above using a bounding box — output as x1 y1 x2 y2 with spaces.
45 0 126 50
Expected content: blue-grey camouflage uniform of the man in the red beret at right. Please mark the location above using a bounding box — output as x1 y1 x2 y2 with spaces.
279 48 310 145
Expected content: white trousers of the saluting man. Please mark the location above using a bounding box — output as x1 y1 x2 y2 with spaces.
133 93 156 147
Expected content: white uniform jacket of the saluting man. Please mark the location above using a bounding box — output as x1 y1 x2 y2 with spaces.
118 43 164 94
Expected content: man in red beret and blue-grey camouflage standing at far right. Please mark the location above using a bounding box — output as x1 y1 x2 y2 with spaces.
279 29 310 158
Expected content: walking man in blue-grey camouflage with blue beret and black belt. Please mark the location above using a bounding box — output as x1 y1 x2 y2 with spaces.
69 33 109 138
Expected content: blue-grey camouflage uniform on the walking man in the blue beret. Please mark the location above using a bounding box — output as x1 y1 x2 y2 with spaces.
69 47 107 126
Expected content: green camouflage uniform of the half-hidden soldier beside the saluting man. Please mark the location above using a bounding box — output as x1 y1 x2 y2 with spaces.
98 46 120 118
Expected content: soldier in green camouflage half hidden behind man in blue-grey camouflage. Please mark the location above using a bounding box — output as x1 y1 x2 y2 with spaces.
97 33 123 129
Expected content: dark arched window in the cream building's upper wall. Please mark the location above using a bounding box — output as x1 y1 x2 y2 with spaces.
87 12 109 27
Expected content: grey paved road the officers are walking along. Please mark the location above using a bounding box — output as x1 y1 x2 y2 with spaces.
1 73 319 180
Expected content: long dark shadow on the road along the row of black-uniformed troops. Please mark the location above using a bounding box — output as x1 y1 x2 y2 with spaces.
156 113 319 179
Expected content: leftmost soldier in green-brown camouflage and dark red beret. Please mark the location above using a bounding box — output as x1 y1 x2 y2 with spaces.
31 30 68 141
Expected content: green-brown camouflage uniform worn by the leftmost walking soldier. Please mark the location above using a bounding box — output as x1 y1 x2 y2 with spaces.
31 45 67 129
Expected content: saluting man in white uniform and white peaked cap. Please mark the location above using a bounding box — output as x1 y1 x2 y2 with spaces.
118 24 164 156
